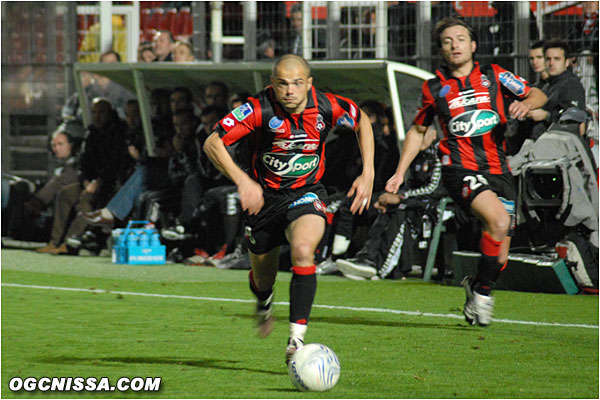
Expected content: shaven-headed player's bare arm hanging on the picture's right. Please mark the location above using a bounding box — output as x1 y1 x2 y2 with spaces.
347 110 375 214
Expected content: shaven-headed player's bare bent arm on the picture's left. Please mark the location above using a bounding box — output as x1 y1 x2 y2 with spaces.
204 132 265 215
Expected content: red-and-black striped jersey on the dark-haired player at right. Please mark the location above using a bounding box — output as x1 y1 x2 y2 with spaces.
413 62 531 174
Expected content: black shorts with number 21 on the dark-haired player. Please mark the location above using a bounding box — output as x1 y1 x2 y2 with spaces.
442 167 517 236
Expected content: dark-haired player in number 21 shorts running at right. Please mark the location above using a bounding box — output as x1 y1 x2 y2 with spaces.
386 18 546 326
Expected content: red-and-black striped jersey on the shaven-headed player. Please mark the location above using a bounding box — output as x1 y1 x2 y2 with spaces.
215 86 360 190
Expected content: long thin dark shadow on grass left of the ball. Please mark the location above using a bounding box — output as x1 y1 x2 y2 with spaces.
38 357 287 375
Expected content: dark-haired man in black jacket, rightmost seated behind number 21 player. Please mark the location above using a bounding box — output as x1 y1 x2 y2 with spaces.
527 41 585 140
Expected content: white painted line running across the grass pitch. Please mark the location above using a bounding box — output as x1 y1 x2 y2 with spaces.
2 283 599 329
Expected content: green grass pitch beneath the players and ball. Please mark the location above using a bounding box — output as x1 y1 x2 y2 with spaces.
0 250 599 398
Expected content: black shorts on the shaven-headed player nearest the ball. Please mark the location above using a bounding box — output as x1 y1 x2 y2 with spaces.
245 183 327 254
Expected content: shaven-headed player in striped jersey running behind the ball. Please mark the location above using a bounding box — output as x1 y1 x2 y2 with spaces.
204 54 374 362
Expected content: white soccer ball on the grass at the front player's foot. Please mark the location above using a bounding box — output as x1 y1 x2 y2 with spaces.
288 343 340 392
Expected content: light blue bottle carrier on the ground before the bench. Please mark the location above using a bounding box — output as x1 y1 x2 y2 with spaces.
112 221 166 264
